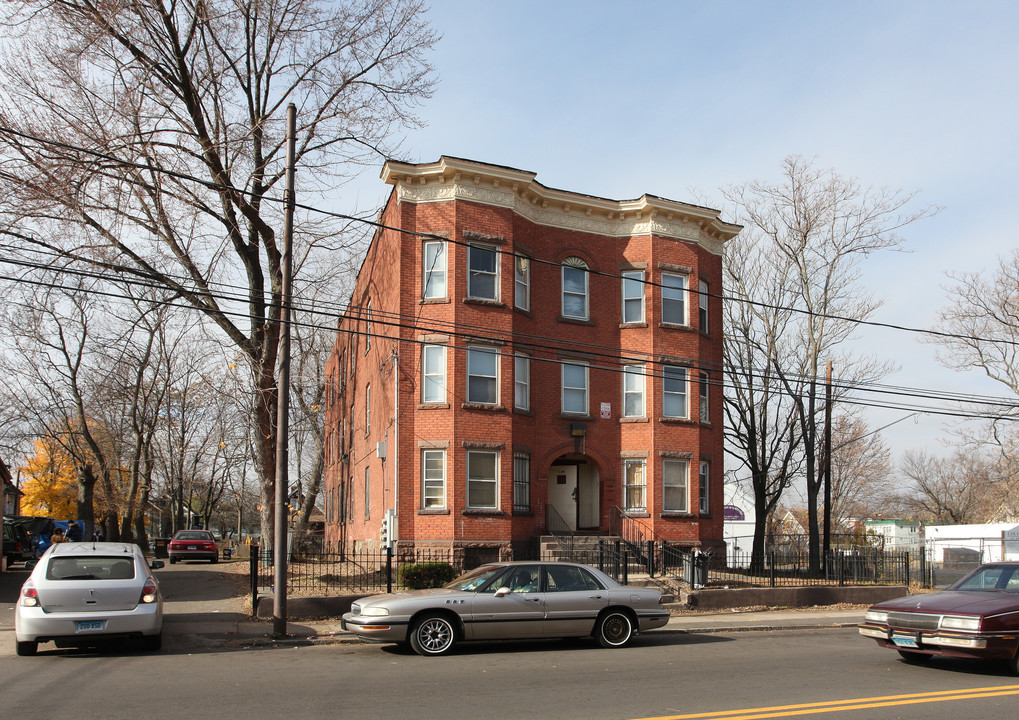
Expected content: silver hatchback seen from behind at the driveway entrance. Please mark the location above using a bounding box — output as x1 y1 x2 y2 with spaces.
14 543 163 655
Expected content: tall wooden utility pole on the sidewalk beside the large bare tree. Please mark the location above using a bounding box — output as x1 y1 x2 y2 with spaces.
272 103 298 635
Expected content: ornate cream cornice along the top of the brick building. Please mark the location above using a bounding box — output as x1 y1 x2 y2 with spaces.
382 156 742 255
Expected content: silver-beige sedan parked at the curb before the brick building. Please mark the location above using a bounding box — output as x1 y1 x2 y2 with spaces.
341 562 668 656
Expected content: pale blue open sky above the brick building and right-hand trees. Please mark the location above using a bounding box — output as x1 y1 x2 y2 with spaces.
347 0 1019 472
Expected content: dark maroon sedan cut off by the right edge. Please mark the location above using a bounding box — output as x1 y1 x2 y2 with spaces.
860 562 1019 674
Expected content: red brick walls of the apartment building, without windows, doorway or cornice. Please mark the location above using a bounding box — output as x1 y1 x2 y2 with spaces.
326 177 723 546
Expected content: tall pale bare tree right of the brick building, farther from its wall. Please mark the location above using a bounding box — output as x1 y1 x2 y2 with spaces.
726 157 931 572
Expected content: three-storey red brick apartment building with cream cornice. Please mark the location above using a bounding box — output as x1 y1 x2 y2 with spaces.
325 157 740 561
